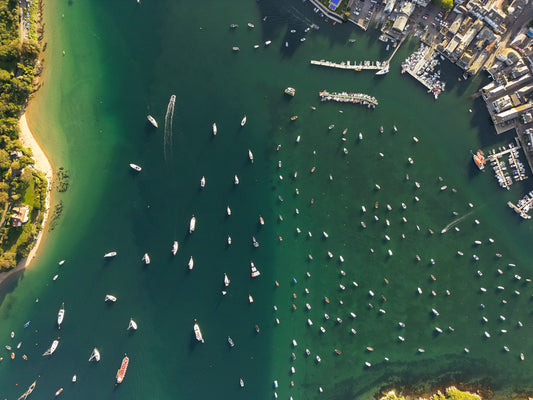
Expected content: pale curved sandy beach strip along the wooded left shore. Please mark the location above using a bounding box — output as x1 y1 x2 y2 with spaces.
0 113 54 286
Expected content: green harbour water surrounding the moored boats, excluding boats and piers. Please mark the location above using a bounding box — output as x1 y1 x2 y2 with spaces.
0 0 533 399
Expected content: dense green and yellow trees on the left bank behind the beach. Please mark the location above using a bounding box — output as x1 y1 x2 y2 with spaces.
0 0 47 271
